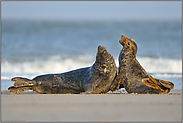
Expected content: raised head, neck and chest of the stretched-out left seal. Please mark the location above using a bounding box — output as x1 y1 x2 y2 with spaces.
91 45 117 93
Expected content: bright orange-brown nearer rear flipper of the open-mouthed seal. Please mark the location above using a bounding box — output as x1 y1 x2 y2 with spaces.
142 75 167 92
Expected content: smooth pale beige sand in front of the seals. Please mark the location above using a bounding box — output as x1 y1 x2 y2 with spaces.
1 90 182 122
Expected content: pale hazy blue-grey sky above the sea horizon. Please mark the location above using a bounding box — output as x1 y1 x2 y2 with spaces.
1 1 182 20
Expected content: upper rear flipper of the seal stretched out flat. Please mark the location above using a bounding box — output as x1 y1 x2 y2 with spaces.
11 77 36 87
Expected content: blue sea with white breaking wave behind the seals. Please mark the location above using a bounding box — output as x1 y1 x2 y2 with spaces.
1 20 182 90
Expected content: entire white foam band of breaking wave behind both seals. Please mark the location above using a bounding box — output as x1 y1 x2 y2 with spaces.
1 56 182 79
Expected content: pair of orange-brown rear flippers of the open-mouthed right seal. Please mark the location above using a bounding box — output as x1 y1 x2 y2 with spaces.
142 75 174 92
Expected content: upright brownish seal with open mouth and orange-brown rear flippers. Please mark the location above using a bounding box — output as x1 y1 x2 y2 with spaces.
110 35 174 94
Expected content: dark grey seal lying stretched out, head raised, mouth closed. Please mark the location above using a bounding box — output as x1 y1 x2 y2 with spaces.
8 45 117 94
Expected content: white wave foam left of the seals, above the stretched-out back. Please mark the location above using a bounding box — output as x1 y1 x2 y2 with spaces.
1 56 94 74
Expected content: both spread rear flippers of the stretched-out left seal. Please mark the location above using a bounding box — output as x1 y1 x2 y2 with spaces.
8 77 36 94
